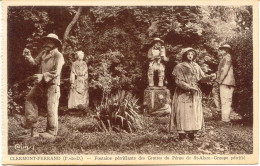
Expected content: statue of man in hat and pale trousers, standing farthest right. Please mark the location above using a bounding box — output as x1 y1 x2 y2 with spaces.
216 44 236 122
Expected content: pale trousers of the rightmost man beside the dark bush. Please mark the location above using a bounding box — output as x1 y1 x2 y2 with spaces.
219 85 234 122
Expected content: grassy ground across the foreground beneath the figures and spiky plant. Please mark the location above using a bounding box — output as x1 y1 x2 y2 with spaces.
8 108 253 154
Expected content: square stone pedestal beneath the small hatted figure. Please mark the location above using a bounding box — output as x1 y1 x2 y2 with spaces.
143 87 171 113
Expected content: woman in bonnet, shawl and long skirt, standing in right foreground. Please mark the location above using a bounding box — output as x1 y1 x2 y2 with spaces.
170 48 213 140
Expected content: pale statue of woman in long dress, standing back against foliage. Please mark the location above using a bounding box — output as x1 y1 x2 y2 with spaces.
68 51 89 109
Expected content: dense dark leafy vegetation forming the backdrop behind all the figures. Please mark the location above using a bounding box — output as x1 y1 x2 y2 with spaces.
8 6 253 122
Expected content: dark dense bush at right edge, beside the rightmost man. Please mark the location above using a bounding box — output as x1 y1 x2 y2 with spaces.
229 29 253 123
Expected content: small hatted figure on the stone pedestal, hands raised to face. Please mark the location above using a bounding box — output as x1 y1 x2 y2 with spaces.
148 38 168 87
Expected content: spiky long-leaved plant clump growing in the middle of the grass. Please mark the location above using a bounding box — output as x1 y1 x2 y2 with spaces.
93 91 142 133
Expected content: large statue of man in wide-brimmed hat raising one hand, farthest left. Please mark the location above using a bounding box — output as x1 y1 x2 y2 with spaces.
22 34 64 138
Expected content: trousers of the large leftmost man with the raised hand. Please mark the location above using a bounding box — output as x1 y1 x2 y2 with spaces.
25 84 60 135
